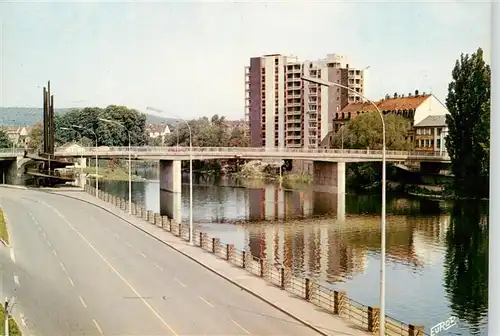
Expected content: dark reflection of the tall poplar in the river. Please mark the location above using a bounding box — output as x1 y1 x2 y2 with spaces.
444 201 488 334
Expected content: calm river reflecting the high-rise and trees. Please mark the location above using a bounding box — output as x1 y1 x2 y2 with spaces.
93 171 488 335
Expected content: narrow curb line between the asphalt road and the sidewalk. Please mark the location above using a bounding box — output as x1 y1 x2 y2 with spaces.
35 190 336 336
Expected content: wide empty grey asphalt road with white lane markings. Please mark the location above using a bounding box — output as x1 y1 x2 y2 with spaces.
0 188 317 336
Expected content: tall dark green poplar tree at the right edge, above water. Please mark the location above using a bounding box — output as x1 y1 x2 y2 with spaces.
445 48 491 198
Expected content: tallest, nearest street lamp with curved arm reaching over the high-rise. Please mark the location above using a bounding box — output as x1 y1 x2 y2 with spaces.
301 76 386 336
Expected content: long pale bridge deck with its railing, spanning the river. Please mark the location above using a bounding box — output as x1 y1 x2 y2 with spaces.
54 146 450 163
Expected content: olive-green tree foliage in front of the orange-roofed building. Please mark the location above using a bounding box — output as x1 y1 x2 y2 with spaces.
332 111 413 150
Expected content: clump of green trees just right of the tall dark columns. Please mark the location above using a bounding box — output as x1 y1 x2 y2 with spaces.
54 105 148 146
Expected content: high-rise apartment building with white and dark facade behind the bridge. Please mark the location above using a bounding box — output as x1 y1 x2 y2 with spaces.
245 54 364 148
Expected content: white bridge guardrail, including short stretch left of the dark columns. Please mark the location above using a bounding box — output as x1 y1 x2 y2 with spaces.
0 146 450 161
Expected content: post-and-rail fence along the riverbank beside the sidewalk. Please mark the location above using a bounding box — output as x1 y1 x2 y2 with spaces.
85 185 425 336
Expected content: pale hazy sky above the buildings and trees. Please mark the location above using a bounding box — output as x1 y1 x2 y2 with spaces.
0 0 491 119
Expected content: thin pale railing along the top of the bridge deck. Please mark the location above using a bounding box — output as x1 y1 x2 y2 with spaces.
52 146 448 158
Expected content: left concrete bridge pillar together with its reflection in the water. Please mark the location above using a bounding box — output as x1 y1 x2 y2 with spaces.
159 160 182 223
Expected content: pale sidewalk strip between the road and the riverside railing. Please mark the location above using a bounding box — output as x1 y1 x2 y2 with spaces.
51 191 370 336
